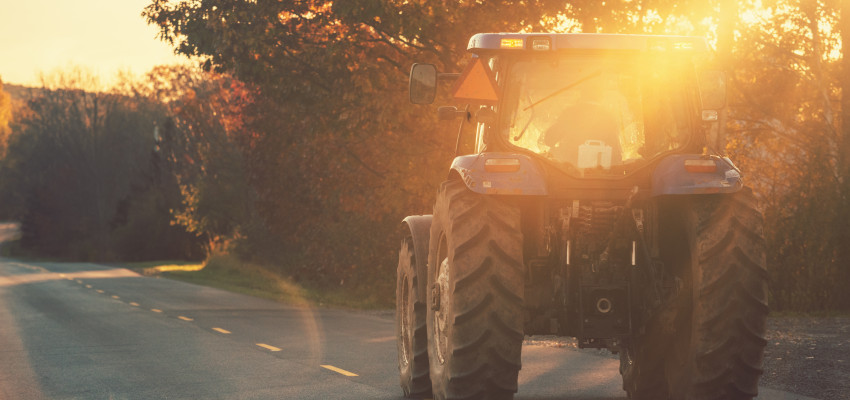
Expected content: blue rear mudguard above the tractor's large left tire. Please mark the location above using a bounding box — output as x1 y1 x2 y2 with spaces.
451 153 549 196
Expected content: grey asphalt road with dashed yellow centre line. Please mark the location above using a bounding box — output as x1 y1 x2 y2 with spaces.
0 227 820 400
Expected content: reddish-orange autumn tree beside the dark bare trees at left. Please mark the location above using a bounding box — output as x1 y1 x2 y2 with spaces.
131 66 253 251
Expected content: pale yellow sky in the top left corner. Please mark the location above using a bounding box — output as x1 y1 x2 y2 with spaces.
0 0 187 86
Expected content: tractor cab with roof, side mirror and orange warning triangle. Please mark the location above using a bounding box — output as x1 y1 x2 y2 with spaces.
411 33 724 178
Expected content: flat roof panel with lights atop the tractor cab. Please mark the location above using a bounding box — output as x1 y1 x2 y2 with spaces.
467 33 708 53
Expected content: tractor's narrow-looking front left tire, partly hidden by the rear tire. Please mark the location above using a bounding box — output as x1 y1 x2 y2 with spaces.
395 236 431 398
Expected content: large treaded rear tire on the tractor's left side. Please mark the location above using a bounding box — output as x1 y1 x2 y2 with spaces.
427 181 525 400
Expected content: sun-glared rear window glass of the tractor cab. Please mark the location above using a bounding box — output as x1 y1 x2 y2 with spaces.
502 55 689 175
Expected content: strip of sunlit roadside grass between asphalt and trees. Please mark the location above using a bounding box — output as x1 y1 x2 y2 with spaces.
121 254 393 309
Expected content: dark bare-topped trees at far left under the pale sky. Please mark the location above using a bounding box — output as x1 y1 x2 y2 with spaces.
0 70 202 260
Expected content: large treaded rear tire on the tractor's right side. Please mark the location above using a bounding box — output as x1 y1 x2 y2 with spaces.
665 188 768 400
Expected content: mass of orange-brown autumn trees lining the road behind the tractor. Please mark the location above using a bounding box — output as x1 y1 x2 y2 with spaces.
0 0 850 310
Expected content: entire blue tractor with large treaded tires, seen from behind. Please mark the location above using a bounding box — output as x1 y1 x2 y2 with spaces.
396 33 768 400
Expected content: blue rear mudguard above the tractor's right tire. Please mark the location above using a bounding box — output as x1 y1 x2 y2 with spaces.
652 154 744 196
